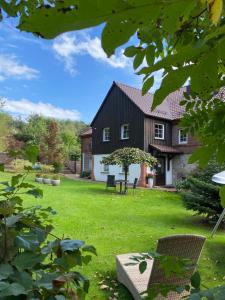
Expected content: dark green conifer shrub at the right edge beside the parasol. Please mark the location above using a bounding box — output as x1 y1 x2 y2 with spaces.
176 161 224 223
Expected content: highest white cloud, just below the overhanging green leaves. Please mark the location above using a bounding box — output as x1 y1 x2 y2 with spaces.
53 33 131 74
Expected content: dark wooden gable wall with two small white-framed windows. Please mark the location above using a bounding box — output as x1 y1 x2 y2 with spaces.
92 86 144 154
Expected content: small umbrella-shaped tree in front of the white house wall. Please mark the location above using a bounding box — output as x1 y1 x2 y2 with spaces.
101 147 157 192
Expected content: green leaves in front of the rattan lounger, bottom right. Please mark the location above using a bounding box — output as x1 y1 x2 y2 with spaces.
131 251 225 300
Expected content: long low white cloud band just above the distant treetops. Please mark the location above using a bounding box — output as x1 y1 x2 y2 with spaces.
1 98 80 120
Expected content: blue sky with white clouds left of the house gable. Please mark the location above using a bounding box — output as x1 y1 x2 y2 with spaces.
0 21 162 123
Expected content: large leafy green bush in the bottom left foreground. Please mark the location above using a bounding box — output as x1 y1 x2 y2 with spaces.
0 158 96 300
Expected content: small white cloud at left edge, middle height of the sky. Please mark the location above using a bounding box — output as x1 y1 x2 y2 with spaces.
0 54 39 81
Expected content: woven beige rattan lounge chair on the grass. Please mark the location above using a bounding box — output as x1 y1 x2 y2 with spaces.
116 234 205 300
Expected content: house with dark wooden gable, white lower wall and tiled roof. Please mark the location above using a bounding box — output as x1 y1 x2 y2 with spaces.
81 82 198 186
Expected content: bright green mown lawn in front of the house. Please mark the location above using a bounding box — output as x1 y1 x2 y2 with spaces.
1 174 225 300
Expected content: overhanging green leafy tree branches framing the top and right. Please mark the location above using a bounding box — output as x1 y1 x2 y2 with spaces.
0 0 225 165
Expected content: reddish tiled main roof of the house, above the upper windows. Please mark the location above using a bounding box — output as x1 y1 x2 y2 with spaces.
115 82 187 120
